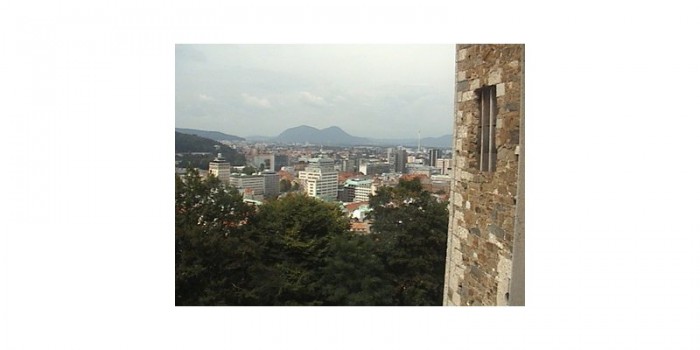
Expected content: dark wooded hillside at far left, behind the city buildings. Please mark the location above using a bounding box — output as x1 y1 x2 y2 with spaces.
175 131 245 170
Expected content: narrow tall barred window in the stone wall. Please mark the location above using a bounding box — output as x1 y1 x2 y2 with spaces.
478 85 497 172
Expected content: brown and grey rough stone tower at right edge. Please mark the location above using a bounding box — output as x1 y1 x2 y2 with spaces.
443 45 525 305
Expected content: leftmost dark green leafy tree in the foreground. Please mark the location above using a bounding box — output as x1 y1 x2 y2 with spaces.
175 169 260 305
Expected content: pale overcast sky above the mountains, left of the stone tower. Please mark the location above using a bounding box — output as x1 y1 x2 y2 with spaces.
175 45 455 138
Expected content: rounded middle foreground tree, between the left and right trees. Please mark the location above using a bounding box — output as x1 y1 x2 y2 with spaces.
250 194 356 305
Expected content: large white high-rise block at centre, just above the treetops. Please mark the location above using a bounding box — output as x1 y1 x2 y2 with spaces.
299 158 338 201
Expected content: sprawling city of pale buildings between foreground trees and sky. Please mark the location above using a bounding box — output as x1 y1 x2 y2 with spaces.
175 124 452 232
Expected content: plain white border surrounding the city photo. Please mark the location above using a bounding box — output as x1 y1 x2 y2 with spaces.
0 0 700 350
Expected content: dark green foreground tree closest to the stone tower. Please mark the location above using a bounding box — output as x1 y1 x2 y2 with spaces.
370 179 449 305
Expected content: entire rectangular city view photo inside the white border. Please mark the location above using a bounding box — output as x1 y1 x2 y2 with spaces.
175 44 525 306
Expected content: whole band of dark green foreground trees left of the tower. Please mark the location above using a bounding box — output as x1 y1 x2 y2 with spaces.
175 170 447 305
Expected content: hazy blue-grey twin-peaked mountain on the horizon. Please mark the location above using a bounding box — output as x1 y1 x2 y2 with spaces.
274 125 369 145
